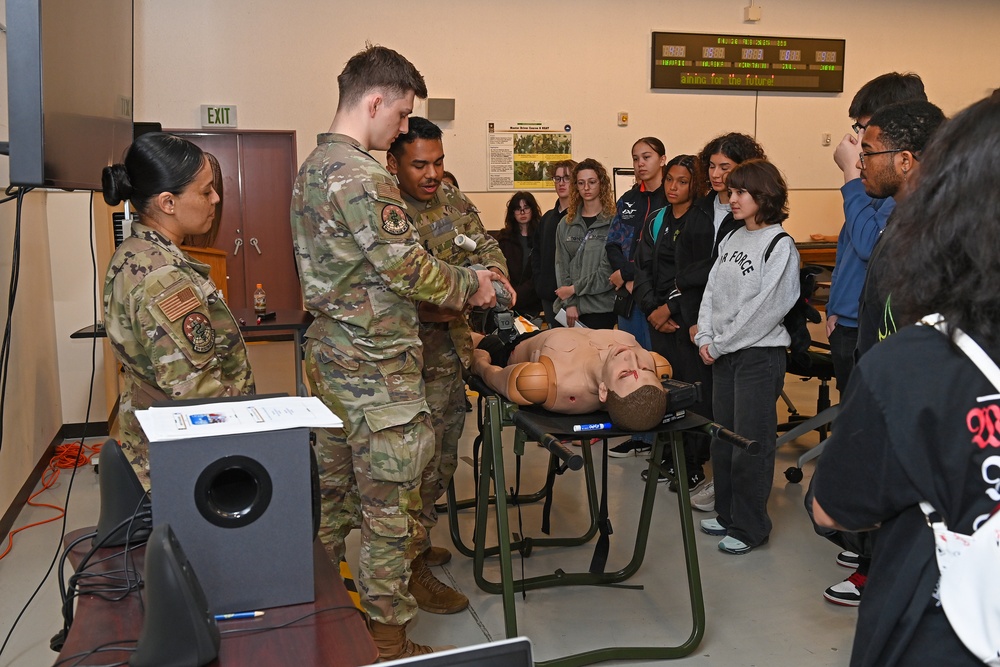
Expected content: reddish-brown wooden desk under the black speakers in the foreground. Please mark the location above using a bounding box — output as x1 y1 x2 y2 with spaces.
59 528 378 667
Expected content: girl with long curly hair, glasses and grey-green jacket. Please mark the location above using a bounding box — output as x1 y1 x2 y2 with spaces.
555 158 618 329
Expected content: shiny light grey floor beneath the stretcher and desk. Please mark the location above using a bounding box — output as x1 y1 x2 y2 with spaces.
0 376 856 667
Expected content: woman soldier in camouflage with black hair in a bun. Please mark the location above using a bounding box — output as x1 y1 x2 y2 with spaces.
103 133 254 489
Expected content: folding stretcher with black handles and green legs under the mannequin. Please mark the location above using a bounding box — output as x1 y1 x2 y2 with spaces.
442 377 759 667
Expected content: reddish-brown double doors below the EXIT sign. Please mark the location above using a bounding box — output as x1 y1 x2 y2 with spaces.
167 130 302 310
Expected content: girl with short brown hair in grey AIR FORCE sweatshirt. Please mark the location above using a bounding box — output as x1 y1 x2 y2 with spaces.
695 160 799 554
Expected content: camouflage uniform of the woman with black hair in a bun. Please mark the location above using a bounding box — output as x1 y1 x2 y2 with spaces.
104 223 254 488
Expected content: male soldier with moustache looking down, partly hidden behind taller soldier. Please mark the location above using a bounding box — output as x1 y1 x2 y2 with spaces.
387 117 513 614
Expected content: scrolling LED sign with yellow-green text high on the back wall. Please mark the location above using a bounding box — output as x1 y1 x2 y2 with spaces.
650 32 845 93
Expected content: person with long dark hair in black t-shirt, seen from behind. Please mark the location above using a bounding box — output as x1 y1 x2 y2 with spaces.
813 92 1000 667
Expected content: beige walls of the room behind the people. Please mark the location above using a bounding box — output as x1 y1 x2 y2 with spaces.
0 0 1000 500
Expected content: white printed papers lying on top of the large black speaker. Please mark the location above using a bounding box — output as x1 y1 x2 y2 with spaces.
135 396 344 442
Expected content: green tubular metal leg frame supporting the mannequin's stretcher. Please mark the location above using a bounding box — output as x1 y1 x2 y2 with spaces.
460 396 709 667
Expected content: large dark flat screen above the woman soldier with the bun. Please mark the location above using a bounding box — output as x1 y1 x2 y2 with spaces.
7 0 132 190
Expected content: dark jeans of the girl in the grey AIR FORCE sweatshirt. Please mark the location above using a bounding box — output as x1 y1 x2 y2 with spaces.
712 347 785 547
